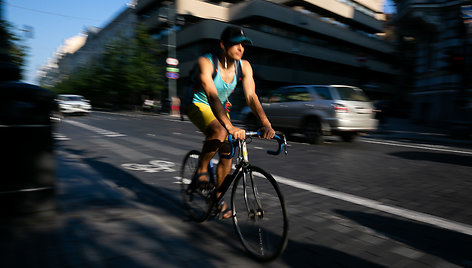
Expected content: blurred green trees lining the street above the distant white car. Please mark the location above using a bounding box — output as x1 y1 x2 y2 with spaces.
53 22 164 108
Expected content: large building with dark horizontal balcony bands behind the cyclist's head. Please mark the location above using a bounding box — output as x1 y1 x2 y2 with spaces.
135 0 399 110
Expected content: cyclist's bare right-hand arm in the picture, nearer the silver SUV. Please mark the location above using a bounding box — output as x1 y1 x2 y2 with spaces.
242 60 275 139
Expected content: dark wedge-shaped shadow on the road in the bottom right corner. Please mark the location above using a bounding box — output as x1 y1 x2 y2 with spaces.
334 210 472 267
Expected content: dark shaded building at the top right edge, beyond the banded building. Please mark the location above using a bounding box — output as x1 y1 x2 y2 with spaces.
394 0 472 128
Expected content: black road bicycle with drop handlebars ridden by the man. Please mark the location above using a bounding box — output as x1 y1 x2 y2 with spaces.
180 132 288 261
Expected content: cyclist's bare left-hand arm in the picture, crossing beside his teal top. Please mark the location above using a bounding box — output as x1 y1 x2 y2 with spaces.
198 57 245 139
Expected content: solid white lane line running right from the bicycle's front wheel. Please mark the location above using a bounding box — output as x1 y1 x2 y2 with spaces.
273 175 472 235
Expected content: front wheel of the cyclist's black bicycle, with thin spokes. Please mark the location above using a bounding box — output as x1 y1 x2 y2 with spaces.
231 166 288 261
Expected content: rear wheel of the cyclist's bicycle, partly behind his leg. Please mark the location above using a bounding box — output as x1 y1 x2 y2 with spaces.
180 150 213 222
